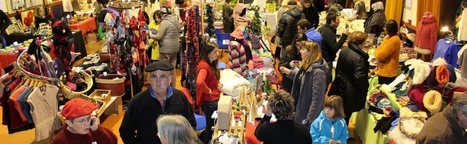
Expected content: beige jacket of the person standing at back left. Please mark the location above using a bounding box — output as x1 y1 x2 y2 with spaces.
152 15 181 53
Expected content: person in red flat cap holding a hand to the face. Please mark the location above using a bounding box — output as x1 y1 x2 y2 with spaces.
52 98 117 144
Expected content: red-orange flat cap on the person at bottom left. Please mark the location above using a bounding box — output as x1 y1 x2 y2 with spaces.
61 98 99 119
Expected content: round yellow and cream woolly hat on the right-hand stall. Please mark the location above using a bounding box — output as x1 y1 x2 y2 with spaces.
423 90 443 114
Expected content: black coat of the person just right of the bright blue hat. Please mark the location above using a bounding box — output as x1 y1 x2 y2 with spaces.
318 24 347 63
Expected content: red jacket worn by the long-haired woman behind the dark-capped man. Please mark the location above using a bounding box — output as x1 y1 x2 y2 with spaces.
196 60 221 107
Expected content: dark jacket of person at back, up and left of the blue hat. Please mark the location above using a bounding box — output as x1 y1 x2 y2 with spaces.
276 8 305 47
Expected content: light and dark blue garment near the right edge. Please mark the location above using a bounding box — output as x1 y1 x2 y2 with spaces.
432 39 459 67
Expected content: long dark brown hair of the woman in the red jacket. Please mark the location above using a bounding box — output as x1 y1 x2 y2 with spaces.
199 42 221 79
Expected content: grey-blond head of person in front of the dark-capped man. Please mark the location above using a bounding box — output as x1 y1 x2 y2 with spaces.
157 115 200 144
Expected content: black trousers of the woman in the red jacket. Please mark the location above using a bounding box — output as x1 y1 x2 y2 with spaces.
201 101 218 144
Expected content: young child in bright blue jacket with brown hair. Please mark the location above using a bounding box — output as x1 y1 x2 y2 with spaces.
310 95 349 144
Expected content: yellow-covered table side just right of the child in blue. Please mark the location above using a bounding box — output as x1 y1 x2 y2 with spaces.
350 108 389 144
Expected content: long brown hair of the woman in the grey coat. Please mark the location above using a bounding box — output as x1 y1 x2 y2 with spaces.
301 41 323 70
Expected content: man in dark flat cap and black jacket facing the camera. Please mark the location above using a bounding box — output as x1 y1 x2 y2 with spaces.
120 61 196 144
